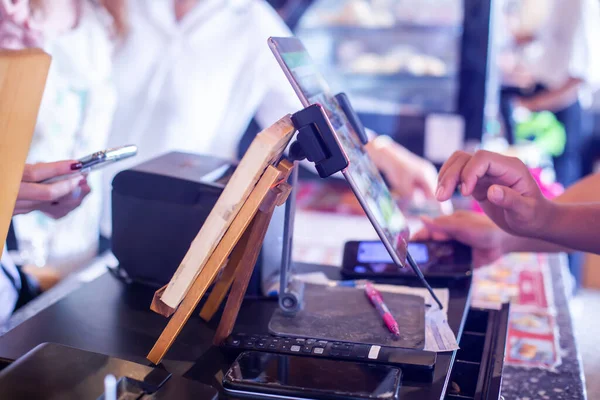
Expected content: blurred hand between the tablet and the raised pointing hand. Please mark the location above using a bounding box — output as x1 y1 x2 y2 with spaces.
367 136 437 199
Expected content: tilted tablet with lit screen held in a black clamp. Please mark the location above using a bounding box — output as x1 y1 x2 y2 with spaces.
269 37 409 267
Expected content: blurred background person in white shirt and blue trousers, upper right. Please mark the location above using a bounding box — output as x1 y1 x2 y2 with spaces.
502 0 600 186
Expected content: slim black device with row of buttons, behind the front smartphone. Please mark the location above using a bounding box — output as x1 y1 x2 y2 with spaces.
224 333 437 371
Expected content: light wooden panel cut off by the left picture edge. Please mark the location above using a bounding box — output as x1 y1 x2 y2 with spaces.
0 49 51 251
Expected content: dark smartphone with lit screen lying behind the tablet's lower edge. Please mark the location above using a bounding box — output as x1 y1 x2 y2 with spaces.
342 240 472 279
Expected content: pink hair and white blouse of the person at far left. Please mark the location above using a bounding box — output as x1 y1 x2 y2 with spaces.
0 0 120 270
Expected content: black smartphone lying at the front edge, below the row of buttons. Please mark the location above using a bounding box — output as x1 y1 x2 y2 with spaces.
223 351 402 400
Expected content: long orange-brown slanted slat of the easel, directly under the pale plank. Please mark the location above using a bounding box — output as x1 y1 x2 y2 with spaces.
148 166 283 364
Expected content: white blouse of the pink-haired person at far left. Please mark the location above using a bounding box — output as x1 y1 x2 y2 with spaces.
14 0 116 272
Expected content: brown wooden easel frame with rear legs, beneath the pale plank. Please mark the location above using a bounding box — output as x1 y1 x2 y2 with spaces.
147 160 293 364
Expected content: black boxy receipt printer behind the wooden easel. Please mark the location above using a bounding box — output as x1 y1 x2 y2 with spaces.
112 152 285 295
